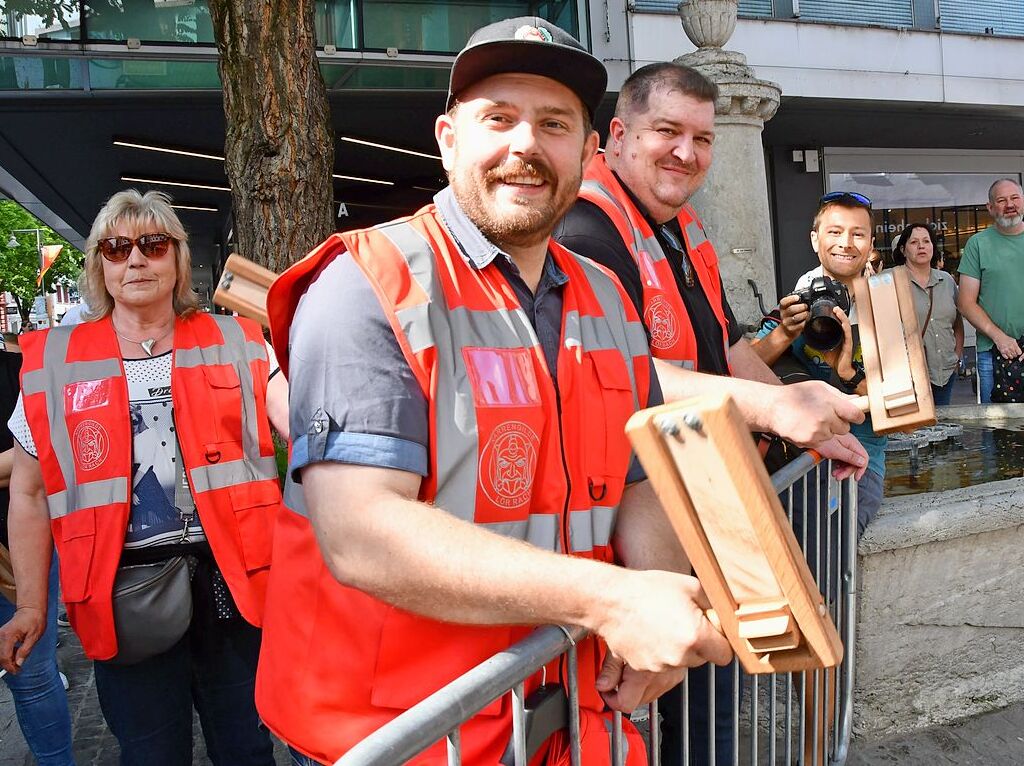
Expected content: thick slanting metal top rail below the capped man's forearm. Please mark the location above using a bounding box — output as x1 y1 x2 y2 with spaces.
335 626 587 766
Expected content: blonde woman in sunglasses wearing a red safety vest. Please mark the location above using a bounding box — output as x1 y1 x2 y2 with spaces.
0 189 283 766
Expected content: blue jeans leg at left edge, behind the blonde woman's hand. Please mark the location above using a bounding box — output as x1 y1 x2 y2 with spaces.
0 556 75 766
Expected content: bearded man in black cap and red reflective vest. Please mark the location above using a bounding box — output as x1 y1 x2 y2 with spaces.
257 17 731 764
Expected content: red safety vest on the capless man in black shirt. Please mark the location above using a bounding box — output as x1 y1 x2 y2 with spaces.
580 155 729 370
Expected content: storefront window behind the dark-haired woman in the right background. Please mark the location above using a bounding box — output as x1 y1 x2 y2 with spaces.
828 173 1004 273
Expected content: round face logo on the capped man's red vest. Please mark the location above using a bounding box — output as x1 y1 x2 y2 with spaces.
480 420 541 508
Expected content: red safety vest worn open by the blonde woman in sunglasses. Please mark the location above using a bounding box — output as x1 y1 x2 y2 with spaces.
22 313 281 659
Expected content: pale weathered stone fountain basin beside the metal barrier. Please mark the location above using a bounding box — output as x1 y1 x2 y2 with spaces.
854 405 1024 739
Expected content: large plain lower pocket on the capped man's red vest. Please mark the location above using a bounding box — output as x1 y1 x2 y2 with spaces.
370 608 512 716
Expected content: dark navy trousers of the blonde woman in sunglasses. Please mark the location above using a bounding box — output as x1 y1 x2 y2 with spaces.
94 609 274 766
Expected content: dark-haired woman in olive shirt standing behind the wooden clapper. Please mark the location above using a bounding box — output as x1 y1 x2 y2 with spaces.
893 223 964 406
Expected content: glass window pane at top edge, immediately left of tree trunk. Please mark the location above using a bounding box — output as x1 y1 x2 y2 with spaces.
84 0 214 45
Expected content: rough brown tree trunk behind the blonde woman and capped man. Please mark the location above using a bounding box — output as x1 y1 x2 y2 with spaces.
209 0 334 272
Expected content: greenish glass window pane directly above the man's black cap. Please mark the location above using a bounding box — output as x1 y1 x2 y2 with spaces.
362 0 579 53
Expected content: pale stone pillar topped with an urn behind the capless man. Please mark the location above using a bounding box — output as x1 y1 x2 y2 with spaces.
676 0 781 325
